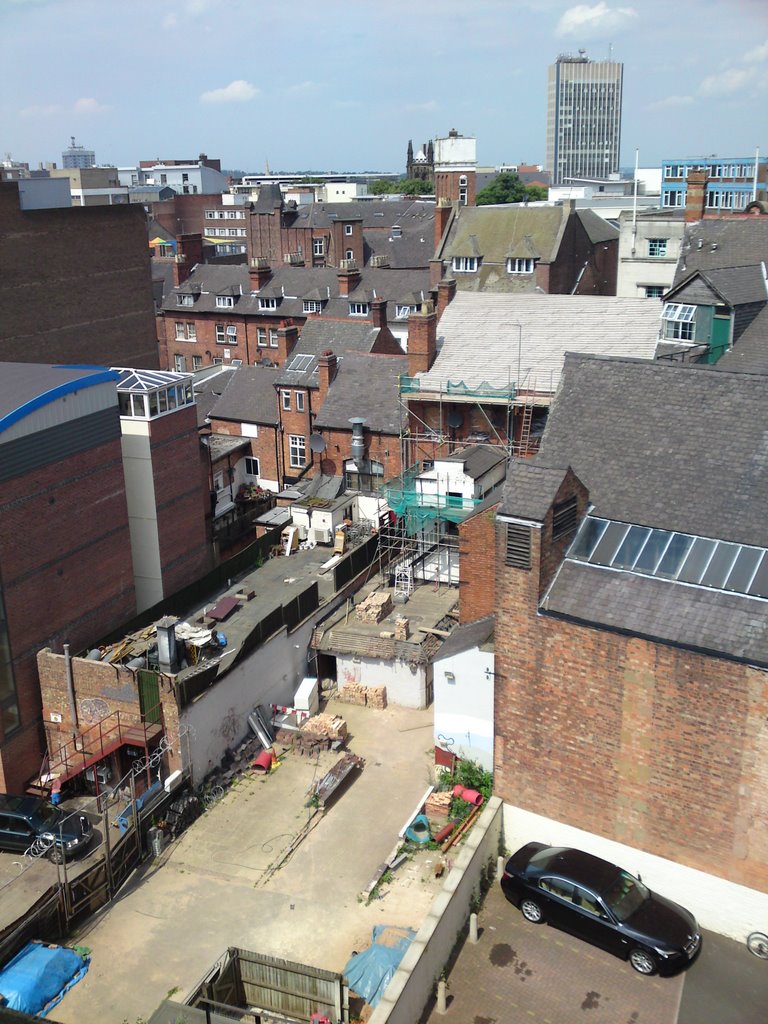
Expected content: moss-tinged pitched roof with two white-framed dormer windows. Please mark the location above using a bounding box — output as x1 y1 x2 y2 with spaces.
435 204 618 292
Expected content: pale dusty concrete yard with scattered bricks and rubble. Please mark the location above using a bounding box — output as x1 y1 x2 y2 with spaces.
54 703 435 1024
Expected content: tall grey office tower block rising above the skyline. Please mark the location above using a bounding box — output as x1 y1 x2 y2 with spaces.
547 50 624 185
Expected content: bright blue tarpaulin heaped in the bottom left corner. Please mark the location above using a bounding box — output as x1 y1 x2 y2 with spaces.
0 942 88 1017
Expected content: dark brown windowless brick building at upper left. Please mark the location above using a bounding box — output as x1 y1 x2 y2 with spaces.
0 182 159 368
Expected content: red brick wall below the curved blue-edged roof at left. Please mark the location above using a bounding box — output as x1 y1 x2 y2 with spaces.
0 439 136 791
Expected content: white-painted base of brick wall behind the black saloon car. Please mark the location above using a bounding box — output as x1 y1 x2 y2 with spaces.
504 804 768 942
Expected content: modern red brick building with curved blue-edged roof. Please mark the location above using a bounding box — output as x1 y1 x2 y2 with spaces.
0 362 136 793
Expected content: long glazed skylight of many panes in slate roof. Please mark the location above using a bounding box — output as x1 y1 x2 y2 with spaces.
567 516 768 598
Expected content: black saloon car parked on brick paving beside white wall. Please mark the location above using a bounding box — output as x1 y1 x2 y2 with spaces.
502 843 701 974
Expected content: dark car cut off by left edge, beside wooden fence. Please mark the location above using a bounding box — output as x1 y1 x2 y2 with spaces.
0 794 93 864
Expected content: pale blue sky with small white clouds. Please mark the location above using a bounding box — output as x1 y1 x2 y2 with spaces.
0 0 768 173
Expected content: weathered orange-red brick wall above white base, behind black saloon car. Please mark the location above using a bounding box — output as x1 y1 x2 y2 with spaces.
495 479 768 890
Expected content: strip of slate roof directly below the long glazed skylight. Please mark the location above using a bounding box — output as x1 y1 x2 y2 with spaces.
542 561 768 667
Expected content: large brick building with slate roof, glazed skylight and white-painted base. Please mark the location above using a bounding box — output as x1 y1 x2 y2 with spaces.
495 354 768 935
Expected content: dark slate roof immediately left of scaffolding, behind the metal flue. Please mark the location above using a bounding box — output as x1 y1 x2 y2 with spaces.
314 352 408 435
